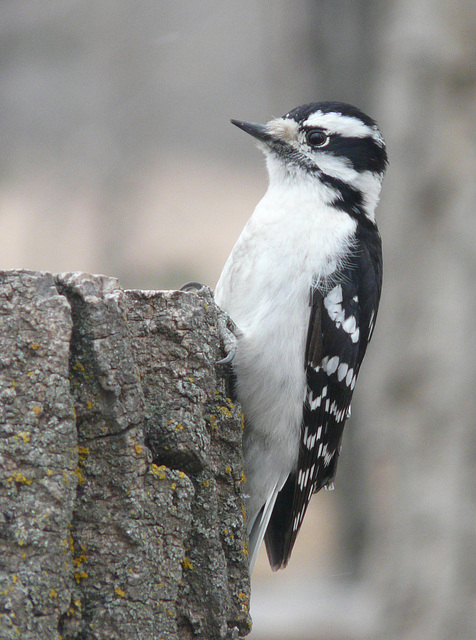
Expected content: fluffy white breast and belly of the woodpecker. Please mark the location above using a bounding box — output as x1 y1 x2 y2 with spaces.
215 178 356 518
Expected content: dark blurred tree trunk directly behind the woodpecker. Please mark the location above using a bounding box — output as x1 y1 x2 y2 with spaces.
299 0 385 580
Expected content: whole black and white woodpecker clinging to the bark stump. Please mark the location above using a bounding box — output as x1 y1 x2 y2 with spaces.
214 102 387 570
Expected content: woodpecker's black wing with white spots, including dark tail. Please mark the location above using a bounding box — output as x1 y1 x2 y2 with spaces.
265 230 382 570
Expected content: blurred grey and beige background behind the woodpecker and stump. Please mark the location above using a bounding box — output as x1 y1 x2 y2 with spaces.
0 0 476 640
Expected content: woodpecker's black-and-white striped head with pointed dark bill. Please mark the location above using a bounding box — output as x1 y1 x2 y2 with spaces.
231 102 387 221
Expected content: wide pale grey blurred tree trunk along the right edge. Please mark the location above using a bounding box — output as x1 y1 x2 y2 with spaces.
360 0 476 640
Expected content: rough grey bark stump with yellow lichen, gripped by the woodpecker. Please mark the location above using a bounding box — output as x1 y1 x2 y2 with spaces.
0 271 250 640
